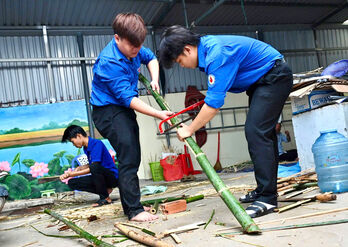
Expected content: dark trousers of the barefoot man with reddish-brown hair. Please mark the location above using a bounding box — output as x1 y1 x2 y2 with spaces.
92 105 144 219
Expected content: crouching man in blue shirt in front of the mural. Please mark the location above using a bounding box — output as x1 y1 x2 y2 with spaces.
60 125 118 206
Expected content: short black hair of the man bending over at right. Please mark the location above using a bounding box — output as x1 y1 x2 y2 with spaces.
159 25 201 69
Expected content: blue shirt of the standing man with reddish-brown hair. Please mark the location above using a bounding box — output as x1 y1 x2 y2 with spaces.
90 39 156 107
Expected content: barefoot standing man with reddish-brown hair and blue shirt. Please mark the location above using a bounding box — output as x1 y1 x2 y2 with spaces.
90 13 172 221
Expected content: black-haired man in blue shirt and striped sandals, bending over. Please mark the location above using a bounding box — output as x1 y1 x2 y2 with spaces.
159 26 292 217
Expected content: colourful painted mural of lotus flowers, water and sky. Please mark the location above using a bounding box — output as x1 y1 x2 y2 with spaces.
0 100 114 200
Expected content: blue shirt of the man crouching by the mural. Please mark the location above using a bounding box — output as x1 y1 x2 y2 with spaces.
83 137 118 178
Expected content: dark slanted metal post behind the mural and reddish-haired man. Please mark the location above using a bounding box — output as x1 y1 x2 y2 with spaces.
77 32 95 138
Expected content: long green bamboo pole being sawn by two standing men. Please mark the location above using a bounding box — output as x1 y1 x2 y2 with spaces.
139 73 261 233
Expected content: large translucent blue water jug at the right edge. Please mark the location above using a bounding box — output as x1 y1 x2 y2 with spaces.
312 129 348 192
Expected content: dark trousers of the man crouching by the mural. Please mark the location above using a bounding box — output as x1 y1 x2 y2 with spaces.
68 163 118 199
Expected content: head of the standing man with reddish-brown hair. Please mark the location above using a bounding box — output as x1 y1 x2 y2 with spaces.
112 13 147 59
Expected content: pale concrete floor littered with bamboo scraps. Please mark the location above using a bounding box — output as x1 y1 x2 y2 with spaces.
0 172 348 247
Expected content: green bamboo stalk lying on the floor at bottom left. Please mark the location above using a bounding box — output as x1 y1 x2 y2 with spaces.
44 208 113 247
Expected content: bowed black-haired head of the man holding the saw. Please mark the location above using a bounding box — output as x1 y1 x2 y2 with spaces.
159 25 200 69
